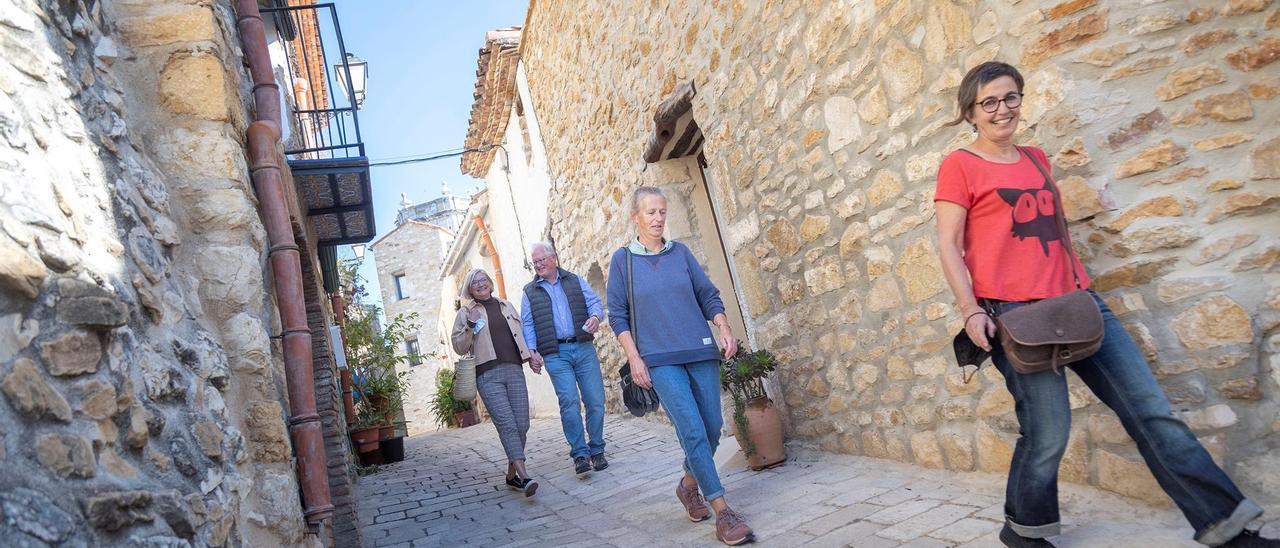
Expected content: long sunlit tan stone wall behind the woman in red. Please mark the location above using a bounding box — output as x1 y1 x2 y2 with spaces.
521 0 1280 508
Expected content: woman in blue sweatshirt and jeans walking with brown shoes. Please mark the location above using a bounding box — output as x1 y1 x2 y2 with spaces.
605 187 753 545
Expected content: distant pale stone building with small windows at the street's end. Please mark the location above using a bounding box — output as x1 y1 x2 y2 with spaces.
372 220 453 434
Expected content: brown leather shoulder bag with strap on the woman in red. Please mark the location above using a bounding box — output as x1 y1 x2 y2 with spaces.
995 147 1103 375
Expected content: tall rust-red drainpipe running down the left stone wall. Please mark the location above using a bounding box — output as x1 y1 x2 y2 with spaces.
236 0 333 524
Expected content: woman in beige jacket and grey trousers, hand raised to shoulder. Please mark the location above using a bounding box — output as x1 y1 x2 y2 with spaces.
452 269 543 497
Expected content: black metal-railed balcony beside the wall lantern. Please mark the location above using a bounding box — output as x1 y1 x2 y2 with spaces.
262 0 376 246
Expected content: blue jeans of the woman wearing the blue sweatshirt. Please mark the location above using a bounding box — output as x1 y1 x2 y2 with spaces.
649 360 724 501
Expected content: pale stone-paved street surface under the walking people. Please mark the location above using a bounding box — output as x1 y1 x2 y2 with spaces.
357 416 1276 548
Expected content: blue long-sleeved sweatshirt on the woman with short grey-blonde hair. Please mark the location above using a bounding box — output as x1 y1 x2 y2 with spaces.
605 242 724 367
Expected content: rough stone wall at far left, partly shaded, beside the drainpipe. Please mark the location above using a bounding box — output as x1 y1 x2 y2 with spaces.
0 0 316 545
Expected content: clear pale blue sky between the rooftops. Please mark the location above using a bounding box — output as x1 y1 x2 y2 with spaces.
334 0 527 308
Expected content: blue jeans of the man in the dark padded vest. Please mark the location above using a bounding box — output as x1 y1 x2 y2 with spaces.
544 343 604 458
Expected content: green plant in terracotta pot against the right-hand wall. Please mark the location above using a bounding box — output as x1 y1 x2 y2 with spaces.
721 344 787 470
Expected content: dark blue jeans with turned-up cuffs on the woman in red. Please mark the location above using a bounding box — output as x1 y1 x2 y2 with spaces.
992 291 1262 545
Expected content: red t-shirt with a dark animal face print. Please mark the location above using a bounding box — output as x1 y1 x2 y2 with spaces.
933 147 1089 301
